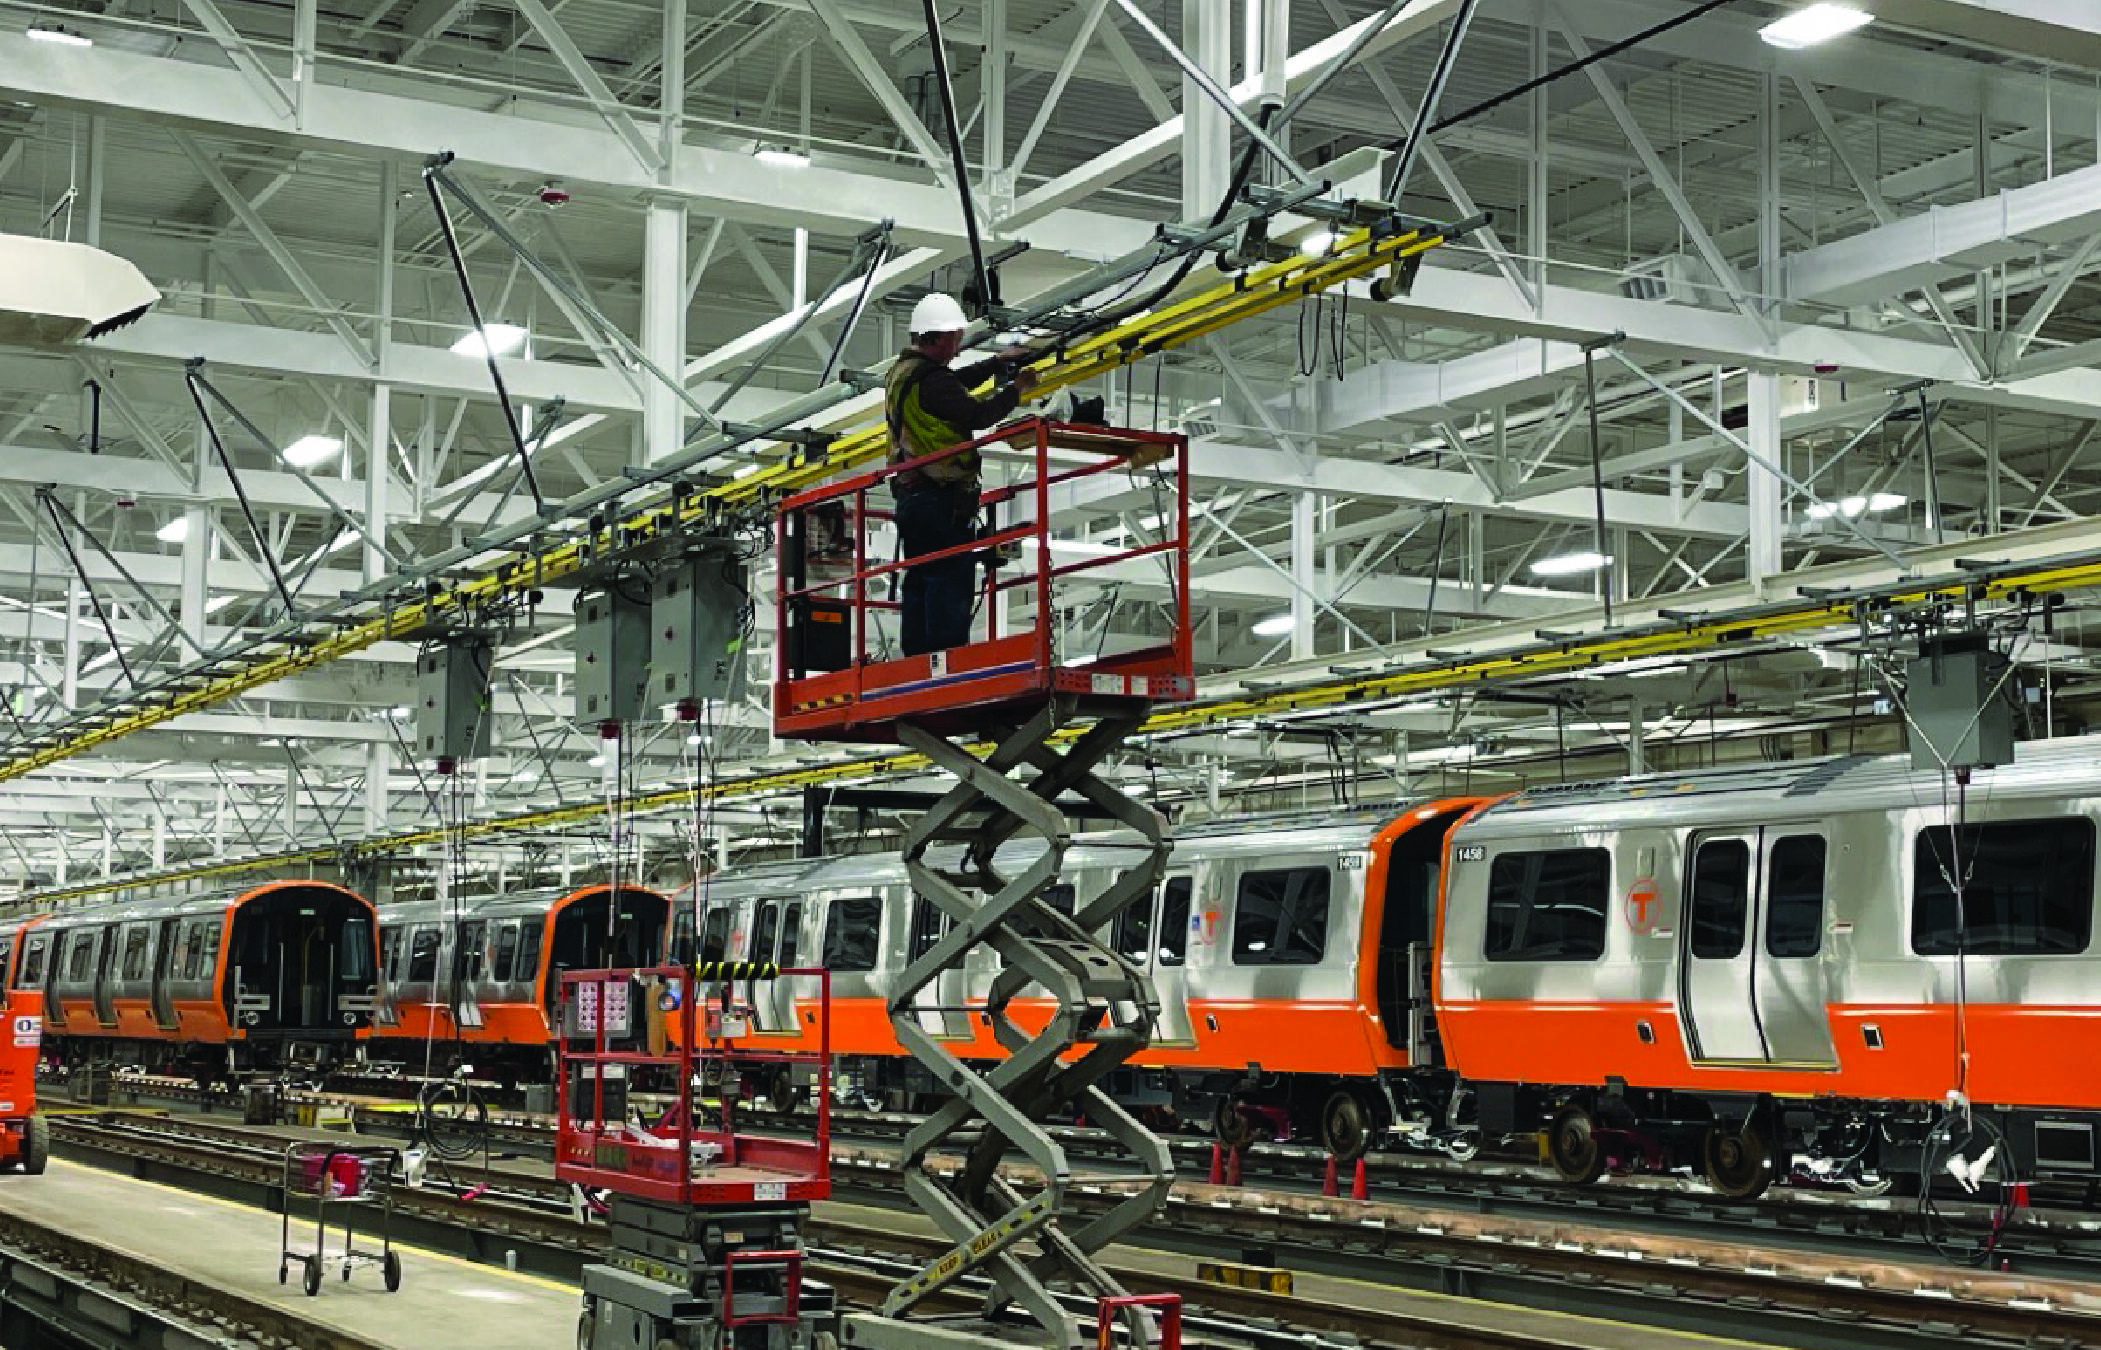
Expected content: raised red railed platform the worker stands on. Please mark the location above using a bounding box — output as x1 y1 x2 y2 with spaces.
773 418 1195 743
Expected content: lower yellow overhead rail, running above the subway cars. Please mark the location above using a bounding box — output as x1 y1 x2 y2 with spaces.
17 537 2101 907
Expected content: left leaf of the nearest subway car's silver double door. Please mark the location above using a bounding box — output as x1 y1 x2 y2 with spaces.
1679 829 1767 1062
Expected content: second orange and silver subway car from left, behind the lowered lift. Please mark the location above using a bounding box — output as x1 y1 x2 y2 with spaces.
372 886 670 1083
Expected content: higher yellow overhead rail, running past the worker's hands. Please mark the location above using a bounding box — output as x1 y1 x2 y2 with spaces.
0 215 1471 781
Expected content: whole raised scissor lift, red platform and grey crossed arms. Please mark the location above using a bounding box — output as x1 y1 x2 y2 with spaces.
775 420 1193 1350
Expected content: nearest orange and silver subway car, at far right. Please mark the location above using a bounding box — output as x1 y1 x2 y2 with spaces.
1435 737 2101 1197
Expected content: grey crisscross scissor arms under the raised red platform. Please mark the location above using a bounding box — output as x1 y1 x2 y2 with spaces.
882 697 1174 1350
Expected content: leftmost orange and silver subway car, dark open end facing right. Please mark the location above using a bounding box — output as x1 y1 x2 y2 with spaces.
0 882 378 1081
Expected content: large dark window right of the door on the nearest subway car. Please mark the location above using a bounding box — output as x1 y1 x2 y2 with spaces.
1912 817 2095 955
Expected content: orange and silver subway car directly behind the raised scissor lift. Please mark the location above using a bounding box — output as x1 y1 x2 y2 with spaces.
672 798 1481 1157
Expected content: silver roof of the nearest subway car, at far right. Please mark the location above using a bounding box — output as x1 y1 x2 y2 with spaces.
1462 737 2101 836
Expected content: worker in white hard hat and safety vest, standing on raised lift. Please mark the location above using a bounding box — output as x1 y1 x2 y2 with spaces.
882 292 1036 657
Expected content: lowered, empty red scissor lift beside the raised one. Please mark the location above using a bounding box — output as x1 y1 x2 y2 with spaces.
555 964 834 1350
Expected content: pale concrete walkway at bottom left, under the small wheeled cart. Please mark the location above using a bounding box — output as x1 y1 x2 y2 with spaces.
0 1161 580 1350
